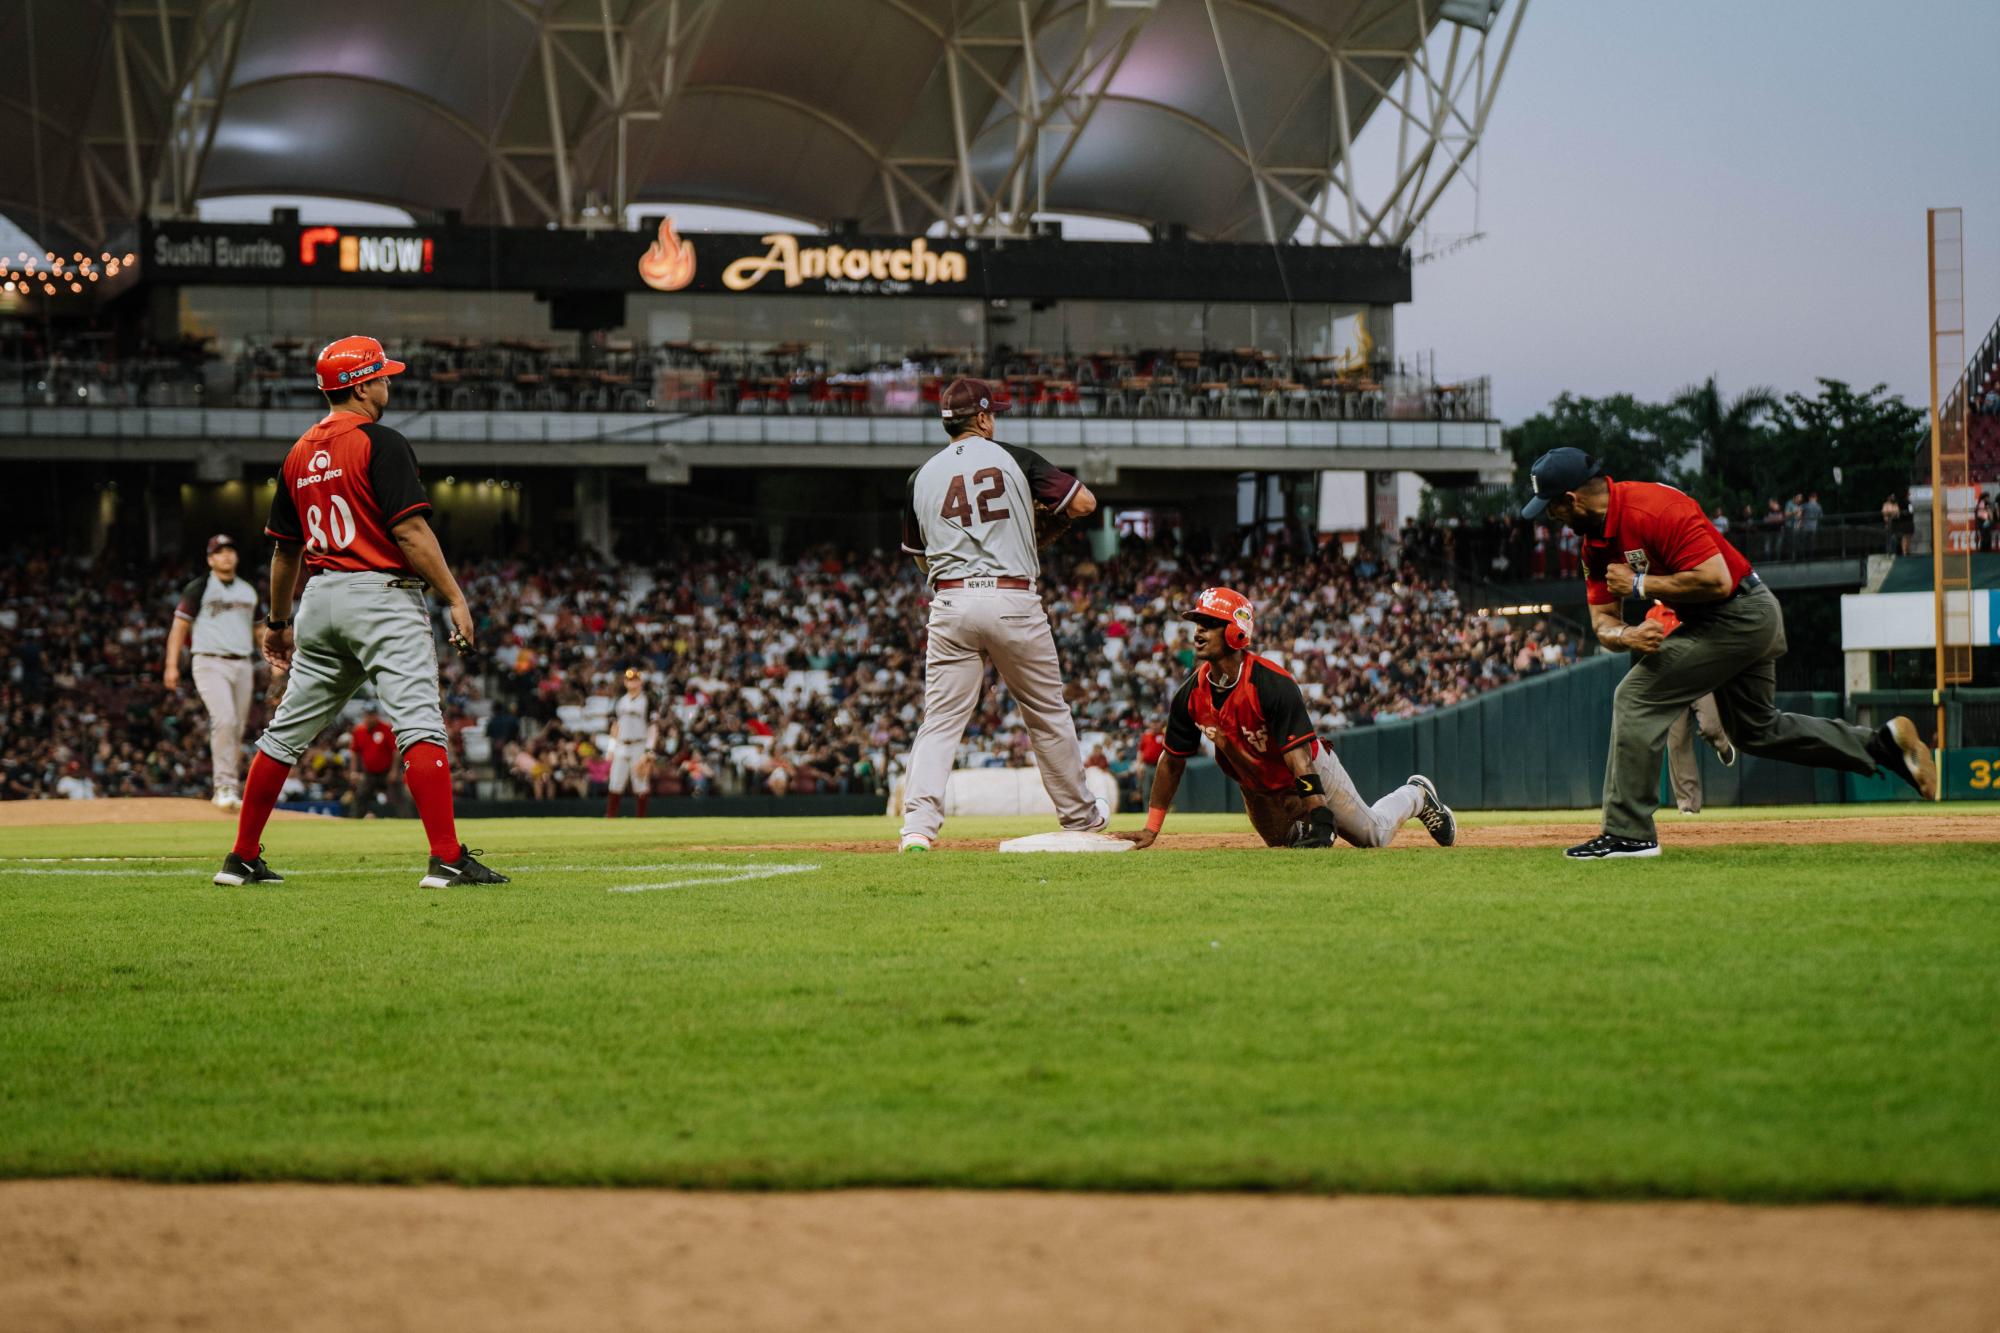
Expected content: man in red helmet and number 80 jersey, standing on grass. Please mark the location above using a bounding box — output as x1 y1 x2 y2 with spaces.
214 338 508 889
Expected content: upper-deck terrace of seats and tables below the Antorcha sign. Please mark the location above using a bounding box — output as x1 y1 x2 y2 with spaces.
0 324 1492 420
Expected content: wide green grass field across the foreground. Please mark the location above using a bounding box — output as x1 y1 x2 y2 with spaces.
0 807 2000 1203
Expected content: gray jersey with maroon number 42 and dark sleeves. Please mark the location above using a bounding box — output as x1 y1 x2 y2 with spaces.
902 434 1082 582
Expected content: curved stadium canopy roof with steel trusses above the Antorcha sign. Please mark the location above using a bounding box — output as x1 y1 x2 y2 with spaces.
0 0 1526 246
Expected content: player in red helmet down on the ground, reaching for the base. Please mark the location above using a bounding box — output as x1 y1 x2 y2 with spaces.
1118 588 1458 849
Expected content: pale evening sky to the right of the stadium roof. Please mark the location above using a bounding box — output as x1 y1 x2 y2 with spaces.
1398 0 2000 422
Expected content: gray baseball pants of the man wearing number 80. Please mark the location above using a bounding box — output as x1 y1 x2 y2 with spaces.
256 572 444 765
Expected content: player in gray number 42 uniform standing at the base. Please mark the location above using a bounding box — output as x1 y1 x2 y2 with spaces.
902 378 1110 853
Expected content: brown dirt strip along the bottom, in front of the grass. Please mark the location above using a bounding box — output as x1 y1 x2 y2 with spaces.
0 1181 2000 1333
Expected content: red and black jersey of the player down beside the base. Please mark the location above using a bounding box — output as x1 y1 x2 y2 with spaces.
1166 652 1320 791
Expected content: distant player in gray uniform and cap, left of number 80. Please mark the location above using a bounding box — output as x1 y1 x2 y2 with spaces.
160 532 264 811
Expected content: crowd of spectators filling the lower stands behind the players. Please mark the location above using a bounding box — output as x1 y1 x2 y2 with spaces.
0 542 1578 803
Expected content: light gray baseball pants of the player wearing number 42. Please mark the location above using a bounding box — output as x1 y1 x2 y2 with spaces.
902 588 1098 839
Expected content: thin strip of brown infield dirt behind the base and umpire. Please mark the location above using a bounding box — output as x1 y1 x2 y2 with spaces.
712 815 2000 855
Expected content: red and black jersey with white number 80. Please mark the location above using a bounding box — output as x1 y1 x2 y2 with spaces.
264 412 430 574
